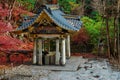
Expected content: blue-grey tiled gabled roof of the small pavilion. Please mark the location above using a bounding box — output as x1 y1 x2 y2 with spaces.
16 5 82 31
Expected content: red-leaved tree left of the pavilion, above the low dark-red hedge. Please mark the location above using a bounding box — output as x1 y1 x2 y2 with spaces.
0 4 33 51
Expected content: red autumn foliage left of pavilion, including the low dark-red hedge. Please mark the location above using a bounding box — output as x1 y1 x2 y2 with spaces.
0 4 33 64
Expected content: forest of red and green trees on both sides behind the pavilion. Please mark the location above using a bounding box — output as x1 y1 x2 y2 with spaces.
0 0 120 67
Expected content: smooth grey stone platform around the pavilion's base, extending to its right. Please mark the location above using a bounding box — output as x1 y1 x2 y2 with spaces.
30 56 88 71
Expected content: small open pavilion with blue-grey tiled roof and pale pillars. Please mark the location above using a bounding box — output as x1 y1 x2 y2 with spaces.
14 0 82 65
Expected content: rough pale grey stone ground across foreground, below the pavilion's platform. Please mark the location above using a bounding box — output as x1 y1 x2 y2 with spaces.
0 58 120 80
